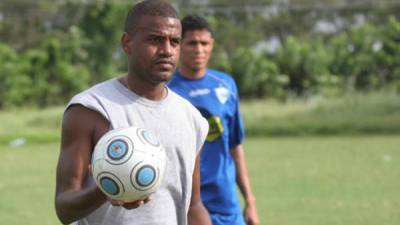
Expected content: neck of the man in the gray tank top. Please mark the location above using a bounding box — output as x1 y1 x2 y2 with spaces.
120 75 167 101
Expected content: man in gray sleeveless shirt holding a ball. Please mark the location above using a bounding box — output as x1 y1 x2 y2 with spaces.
55 0 211 225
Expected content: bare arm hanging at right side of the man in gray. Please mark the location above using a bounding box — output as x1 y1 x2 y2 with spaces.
188 154 211 225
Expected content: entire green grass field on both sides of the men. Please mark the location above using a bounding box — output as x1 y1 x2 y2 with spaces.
0 93 400 225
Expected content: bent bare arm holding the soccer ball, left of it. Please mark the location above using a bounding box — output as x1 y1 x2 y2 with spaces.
55 105 109 224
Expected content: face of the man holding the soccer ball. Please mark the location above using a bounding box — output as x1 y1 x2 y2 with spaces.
122 16 181 85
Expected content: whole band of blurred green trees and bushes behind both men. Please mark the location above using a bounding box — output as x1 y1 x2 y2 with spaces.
0 0 400 108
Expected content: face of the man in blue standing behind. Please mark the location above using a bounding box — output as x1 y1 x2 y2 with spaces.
181 30 214 71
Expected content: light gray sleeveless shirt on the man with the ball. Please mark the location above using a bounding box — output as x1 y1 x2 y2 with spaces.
67 78 208 225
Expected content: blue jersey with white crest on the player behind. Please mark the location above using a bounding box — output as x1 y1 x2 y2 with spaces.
168 69 244 213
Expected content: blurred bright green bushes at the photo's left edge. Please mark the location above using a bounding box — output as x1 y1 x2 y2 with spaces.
0 30 89 108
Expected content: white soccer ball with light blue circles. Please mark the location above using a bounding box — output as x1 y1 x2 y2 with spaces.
92 127 167 202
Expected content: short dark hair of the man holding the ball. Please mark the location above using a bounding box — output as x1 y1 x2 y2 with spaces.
124 0 179 33
